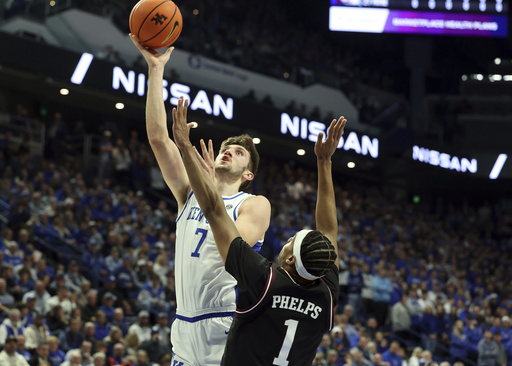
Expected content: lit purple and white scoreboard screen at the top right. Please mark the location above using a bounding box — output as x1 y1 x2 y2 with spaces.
329 0 509 37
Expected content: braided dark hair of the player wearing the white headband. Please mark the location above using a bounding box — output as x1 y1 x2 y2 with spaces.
300 230 338 277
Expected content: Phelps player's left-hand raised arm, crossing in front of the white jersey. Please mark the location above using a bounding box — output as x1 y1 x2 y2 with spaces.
172 98 240 261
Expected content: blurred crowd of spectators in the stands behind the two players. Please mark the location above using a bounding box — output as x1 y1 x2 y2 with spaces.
0 102 512 366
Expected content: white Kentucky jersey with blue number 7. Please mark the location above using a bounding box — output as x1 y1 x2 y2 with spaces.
175 192 263 321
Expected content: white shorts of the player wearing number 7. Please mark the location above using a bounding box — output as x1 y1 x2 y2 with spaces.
171 316 233 366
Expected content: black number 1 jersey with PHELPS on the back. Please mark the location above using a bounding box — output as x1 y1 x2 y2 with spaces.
221 238 339 366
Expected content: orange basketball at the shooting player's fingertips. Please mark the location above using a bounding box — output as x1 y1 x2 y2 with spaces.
130 0 183 49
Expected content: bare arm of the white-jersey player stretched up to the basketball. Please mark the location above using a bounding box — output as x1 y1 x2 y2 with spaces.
130 34 190 211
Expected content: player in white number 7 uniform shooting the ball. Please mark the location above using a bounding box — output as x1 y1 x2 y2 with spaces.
130 35 270 366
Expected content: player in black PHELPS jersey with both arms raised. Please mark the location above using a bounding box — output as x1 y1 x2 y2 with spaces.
173 99 346 366
